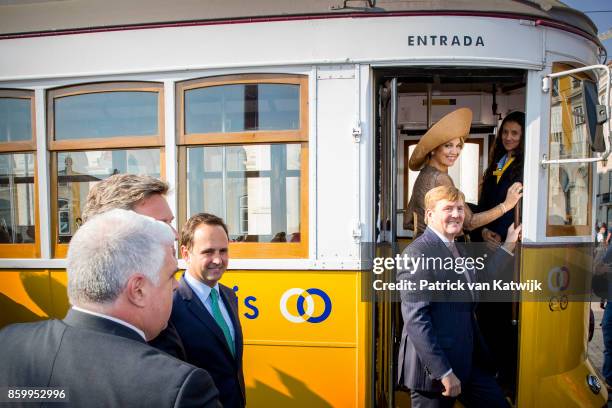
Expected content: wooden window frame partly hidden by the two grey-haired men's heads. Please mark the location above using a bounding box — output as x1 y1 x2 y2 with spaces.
46 81 166 258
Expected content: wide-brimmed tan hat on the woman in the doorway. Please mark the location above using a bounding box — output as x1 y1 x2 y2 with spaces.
408 108 472 171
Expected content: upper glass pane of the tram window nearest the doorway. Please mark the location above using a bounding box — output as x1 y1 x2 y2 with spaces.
185 84 300 134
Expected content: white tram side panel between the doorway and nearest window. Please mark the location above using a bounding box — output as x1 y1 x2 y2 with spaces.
315 65 359 262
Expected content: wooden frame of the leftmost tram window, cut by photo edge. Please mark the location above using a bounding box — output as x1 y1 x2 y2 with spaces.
0 88 40 258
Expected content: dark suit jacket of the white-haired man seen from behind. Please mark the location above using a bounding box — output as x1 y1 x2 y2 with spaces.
0 310 220 408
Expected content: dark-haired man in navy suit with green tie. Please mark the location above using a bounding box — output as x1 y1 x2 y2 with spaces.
152 213 246 408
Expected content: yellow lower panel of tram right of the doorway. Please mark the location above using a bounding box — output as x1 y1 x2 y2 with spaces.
517 245 607 408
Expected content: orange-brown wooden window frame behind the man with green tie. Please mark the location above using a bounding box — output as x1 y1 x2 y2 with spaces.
175 74 309 259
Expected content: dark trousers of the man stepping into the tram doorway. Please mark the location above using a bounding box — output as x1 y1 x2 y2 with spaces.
410 367 510 408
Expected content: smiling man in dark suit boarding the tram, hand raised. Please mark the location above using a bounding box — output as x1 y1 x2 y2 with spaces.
397 186 520 408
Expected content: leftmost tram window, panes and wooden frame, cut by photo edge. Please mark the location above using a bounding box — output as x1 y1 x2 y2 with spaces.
0 89 39 258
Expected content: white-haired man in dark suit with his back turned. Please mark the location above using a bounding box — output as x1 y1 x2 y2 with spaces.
0 209 219 407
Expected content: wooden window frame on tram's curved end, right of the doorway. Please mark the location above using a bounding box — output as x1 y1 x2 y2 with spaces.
546 62 594 237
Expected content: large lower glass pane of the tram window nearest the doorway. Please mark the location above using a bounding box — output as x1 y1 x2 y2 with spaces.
187 144 301 242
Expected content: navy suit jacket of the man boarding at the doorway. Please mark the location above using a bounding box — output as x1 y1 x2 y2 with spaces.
397 228 511 392
